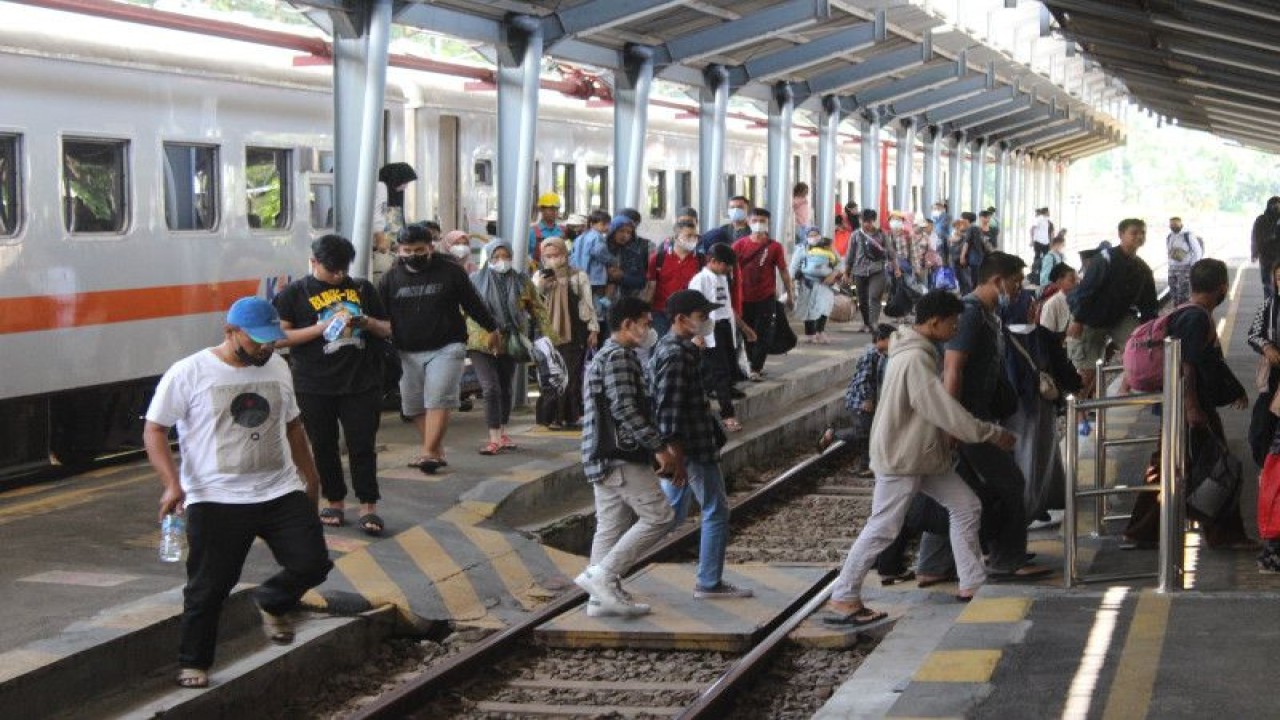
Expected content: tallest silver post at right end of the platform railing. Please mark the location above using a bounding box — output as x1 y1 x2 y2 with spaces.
1157 338 1185 593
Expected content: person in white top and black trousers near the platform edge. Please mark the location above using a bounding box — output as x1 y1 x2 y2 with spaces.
689 242 755 433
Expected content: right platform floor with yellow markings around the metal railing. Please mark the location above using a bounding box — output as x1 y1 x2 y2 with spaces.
815 254 1280 720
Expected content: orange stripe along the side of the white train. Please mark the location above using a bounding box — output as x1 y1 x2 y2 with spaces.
0 278 260 334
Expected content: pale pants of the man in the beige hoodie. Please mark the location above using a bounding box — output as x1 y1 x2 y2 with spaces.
831 470 987 602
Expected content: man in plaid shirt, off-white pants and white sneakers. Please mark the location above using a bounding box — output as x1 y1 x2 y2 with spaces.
573 297 685 618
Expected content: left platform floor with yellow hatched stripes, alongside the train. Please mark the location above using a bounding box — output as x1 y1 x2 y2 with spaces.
0 315 868 706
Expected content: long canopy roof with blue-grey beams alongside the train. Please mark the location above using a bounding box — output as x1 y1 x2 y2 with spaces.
293 0 1126 160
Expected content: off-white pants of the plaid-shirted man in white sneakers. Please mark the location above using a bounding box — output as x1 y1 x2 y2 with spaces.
591 462 675 577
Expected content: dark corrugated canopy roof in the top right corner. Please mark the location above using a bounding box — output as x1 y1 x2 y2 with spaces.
1044 0 1280 152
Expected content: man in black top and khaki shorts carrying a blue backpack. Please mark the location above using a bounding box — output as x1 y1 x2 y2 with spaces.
1066 218 1160 425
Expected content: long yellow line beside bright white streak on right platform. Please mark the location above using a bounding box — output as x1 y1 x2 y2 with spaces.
1102 589 1169 720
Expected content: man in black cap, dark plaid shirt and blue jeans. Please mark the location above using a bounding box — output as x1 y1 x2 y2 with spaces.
649 290 753 598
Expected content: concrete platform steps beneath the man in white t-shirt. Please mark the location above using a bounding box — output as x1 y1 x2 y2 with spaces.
0 587 394 720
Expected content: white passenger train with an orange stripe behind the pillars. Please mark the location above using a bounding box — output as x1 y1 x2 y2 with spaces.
0 11 901 477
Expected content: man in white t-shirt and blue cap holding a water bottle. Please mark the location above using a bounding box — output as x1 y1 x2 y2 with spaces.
142 297 333 688
